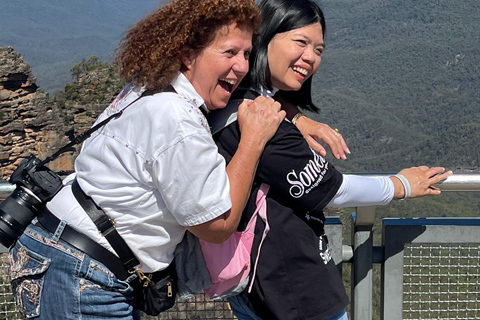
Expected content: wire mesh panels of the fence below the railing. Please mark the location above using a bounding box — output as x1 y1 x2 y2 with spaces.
0 240 480 320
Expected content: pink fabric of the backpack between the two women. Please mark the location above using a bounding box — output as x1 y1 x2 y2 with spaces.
200 184 270 298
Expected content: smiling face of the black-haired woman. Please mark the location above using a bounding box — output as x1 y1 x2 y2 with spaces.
267 22 325 91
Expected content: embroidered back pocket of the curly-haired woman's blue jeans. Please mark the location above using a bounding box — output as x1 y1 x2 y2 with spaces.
9 241 51 318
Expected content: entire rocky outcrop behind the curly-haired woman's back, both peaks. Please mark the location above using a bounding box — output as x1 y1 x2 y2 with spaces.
0 47 121 179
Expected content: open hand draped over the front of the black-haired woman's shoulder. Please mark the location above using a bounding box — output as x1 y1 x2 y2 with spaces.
296 116 350 160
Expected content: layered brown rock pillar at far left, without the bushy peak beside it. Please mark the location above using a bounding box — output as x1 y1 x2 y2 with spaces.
0 47 72 179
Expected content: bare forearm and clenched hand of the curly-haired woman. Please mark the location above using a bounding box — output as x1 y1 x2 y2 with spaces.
187 97 285 243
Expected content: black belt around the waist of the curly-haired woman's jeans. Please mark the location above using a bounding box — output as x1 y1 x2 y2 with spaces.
37 208 129 280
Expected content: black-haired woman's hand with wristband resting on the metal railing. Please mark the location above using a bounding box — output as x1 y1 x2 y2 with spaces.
391 166 453 199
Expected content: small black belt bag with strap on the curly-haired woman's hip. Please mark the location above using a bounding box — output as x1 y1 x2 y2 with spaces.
72 179 178 316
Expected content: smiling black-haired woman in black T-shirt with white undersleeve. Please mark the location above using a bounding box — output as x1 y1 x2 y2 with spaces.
209 0 451 320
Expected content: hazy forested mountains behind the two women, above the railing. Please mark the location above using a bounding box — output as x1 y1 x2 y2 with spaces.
0 0 480 175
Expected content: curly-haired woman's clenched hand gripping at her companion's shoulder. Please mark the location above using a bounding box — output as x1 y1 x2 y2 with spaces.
237 96 285 150
